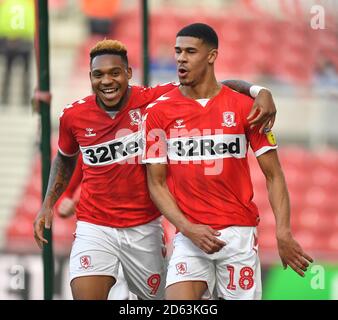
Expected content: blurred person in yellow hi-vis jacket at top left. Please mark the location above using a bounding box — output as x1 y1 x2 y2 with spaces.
0 0 34 105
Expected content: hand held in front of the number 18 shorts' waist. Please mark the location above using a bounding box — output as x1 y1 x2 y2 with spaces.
182 224 226 254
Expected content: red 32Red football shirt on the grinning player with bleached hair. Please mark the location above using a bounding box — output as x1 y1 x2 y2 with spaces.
59 84 176 228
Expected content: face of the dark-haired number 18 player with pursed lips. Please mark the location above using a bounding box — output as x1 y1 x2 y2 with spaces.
175 37 215 86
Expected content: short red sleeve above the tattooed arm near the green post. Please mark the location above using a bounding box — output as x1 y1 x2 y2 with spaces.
58 110 79 157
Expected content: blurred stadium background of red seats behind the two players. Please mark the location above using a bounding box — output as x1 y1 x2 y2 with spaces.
0 0 338 299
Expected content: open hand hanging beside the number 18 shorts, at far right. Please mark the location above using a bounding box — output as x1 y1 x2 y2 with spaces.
277 232 313 277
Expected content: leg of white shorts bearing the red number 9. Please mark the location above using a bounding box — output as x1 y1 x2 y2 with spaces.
121 219 166 300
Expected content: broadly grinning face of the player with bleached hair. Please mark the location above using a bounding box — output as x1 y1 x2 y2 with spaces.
89 54 132 108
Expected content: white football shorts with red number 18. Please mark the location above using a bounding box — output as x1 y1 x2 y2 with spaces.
166 226 262 300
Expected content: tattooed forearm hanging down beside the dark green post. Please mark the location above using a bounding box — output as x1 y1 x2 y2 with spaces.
43 153 76 209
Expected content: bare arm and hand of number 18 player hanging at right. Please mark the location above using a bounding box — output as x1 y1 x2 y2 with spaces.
257 150 313 276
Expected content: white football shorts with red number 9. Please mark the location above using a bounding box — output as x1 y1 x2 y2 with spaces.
69 218 166 300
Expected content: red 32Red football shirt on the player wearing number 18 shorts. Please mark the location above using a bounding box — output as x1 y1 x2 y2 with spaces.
143 86 277 229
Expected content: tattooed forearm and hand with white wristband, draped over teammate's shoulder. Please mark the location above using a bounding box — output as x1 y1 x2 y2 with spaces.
222 80 277 133
